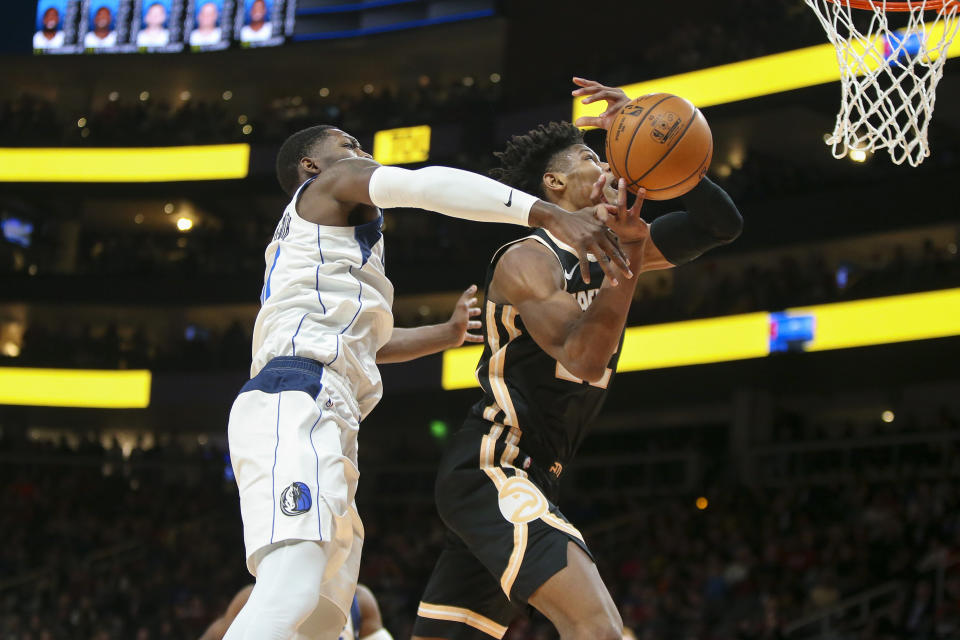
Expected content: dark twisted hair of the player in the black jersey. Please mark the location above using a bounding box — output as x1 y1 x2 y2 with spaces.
490 122 583 198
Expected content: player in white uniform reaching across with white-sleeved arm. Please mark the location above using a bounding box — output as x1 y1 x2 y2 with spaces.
225 125 632 640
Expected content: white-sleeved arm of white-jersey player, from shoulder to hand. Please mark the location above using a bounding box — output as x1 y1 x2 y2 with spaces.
315 158 632 284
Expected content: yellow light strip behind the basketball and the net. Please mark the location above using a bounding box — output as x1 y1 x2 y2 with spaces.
571 17 960 122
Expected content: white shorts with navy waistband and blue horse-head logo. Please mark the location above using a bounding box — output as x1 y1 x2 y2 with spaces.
227 356 363 615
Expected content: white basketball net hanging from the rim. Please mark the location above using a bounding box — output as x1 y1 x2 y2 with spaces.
805 0 960 167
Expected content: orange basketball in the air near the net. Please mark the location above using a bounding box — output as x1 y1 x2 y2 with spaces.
607 93 713 200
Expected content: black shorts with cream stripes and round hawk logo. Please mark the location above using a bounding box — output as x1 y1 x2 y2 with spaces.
414 419 593 640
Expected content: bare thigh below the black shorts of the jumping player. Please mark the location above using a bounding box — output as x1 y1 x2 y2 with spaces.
529 541 622 631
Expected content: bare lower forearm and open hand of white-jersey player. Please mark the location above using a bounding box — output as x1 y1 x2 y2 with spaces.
377 284 483 364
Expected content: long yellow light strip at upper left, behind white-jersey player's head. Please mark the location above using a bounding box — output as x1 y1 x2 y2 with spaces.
0 144 250 182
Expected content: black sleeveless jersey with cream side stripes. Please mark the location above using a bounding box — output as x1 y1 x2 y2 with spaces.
470 229 623 477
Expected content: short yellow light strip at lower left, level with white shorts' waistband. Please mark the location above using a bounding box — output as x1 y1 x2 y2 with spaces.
0 367 151 409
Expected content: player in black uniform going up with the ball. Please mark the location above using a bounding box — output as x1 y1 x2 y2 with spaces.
414 79 742 640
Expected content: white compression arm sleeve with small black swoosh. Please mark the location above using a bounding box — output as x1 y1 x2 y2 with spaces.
370 167 538 226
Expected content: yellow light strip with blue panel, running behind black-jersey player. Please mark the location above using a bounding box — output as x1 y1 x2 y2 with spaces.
441 289 960 389
